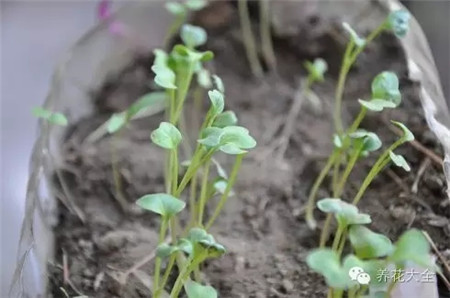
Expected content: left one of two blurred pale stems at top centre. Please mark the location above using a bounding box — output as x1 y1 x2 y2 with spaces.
238 0 263 78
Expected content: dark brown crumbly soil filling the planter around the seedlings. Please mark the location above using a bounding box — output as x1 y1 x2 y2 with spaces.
50 2 450 298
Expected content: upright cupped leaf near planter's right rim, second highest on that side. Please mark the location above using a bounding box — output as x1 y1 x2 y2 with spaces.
371 71 402 106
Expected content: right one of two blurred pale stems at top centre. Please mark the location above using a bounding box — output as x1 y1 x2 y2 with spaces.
259 0 277 69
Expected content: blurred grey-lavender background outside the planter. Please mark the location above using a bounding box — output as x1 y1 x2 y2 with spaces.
0 0 450 297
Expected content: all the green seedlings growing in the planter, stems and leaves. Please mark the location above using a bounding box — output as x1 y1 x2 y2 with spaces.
34 0 438 298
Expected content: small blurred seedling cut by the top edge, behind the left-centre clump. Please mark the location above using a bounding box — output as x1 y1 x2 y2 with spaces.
164 0 208 48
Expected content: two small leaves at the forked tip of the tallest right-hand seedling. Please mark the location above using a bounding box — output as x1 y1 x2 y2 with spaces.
342 9 411 48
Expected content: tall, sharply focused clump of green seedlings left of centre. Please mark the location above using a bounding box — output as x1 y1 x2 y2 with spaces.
137 25 256 298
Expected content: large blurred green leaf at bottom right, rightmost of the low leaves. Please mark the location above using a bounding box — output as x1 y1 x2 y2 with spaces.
389 229 435 269
